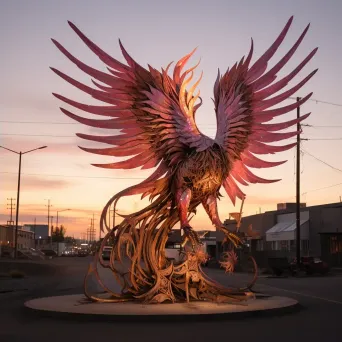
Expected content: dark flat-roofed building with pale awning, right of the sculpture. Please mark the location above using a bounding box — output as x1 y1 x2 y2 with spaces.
217 203 342 267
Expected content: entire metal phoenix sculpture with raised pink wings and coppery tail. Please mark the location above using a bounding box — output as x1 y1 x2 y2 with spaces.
52 17 317 303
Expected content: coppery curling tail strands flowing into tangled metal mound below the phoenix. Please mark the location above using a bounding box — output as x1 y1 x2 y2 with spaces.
84 167 256 303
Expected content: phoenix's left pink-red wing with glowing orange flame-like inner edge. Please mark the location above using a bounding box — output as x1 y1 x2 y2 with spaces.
52 22 212 169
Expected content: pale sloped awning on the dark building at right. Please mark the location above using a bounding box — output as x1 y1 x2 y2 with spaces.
266 220 309 241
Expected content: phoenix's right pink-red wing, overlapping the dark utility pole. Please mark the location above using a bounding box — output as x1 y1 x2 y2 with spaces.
214 17 317 204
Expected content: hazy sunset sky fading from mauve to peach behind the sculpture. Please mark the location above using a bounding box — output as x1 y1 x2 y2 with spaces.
0 0 342 237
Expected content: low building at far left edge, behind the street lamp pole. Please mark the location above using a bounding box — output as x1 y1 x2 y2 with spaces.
0 225 34 250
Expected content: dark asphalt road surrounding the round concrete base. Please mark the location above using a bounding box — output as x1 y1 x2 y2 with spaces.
0 258 342 342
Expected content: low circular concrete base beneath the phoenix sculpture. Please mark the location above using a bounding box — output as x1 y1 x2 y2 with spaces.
25 294 299 321
